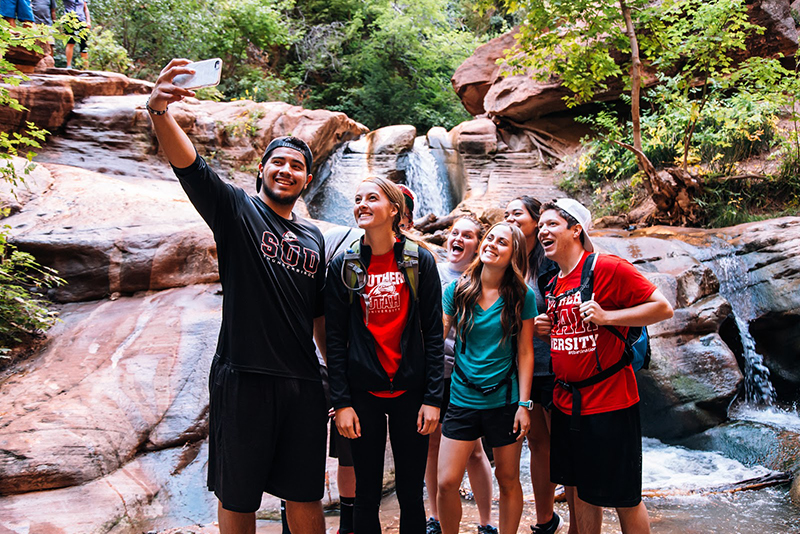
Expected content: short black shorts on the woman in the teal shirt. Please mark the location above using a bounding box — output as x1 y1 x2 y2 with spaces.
442 404 518 448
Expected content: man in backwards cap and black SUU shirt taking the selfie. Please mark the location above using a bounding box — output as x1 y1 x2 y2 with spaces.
146 59 327 534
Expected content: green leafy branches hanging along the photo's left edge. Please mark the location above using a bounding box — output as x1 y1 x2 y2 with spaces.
0 19 63 350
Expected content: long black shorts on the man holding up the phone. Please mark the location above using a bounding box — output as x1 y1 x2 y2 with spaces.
208 358 328 513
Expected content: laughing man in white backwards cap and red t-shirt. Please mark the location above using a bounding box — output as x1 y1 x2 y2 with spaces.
536 199 672 534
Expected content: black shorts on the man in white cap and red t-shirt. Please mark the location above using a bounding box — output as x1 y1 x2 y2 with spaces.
550 403 642 508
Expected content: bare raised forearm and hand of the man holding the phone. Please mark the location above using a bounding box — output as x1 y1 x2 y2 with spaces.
148 59 202 169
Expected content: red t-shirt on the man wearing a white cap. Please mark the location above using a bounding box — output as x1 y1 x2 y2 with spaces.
547 252 656 415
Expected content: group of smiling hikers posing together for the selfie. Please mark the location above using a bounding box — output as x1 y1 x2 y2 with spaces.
146 59 672 534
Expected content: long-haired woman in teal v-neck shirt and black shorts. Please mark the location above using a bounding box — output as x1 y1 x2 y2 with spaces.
438 222 536 534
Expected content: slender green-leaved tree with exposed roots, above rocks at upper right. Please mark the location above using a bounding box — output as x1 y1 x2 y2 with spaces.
504 0 780 221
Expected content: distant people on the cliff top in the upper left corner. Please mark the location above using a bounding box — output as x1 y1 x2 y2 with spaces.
0 0 92 69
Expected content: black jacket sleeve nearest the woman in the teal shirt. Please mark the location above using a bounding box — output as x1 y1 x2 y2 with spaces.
418 247 444 406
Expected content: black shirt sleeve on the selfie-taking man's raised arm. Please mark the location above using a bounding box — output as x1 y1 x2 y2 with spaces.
172 154 237 234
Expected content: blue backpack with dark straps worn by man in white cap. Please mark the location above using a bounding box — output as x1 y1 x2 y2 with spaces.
545 253 650 431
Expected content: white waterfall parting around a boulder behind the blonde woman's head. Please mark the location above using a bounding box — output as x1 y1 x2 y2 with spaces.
304 137 457 226
